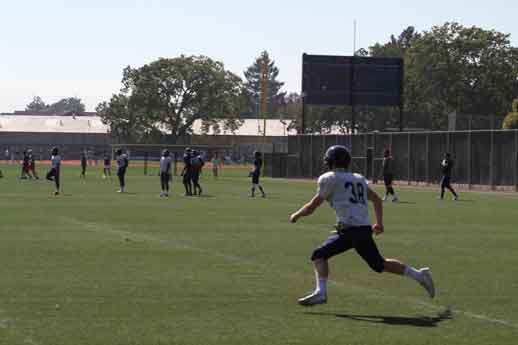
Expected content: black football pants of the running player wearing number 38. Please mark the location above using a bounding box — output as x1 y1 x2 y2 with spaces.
311 226 385 273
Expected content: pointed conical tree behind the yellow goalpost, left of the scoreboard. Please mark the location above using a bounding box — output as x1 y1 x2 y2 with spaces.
244 51 286 116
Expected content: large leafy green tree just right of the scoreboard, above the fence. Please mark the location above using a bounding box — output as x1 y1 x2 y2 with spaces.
405 23 518 129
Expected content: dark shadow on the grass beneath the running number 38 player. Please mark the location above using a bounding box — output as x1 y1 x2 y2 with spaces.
305 311 453 327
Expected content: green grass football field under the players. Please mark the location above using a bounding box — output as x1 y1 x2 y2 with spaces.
0 162 518 345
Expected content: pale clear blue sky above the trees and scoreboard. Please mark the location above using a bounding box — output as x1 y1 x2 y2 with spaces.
0 0 518 112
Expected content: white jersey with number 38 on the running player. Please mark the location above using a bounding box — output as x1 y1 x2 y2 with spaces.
318 169 371 226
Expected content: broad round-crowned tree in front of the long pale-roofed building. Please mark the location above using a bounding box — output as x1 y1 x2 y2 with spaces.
98 55 244 141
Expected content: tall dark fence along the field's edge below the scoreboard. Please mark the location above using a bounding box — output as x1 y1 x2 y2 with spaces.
278 130 518 191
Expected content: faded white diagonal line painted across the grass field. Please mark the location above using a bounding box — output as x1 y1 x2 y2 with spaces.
61 217 518 330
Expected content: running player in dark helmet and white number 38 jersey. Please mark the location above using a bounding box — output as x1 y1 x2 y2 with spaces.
290 145 435 306
